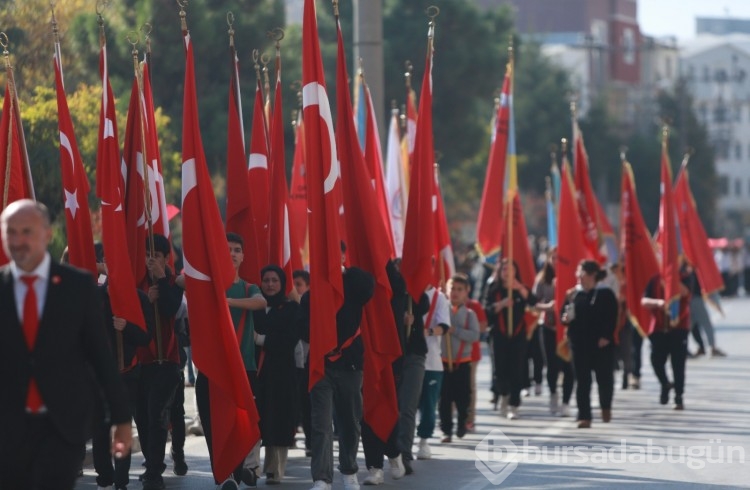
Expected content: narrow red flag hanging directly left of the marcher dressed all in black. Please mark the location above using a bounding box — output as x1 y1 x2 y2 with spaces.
555 156 586 359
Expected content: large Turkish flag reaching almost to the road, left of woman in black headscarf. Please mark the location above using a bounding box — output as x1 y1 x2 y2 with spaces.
182 25 260 481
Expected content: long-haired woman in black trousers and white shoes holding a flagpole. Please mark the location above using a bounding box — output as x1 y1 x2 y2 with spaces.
484 259 537 420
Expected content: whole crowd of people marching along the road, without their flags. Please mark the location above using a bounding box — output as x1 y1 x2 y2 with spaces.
0 201 724 490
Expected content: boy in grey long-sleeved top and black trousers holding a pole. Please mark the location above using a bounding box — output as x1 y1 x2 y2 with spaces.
440 273 479 443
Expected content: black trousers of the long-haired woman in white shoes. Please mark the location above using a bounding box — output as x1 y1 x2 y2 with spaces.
494 332 528 407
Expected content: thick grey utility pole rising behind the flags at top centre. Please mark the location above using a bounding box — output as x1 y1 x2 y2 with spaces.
352 0 385 151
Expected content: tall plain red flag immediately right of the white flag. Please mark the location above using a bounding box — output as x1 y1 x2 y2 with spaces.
401 24 435 298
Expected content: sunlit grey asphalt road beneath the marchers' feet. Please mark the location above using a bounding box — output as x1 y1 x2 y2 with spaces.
76 292 750 490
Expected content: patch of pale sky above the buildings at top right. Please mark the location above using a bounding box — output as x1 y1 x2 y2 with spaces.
638 0 750 41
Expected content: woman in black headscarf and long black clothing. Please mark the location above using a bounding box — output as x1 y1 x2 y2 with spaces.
254 265 300 484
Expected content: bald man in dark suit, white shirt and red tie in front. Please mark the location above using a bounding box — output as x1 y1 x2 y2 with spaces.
0 199 132 490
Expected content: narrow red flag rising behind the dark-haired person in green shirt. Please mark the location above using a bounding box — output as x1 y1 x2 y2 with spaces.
226 40 265 284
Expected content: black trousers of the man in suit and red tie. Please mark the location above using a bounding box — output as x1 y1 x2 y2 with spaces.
0 415 85 490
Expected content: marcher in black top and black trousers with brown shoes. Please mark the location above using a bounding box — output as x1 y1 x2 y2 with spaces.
562 260 618 429
